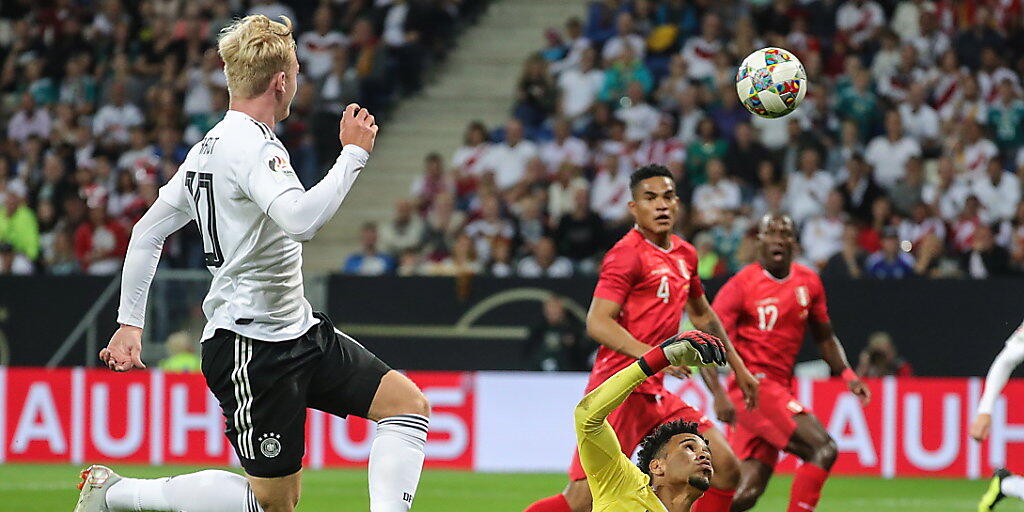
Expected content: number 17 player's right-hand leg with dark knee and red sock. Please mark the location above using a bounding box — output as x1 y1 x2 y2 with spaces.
785 413 839 512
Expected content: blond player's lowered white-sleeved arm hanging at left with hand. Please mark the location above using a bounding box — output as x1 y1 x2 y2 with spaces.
99 196 190 372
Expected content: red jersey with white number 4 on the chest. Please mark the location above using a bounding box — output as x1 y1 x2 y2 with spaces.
587 228 703 394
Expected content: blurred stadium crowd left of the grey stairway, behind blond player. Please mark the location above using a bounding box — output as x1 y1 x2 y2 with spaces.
0 0 486 274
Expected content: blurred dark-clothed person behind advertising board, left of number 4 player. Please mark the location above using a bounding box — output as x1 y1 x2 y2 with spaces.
523 294 595 372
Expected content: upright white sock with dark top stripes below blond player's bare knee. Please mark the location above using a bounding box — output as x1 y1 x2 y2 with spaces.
368 415 430 512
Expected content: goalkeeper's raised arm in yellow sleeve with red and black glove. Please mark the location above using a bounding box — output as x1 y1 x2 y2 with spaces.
574 331 725 497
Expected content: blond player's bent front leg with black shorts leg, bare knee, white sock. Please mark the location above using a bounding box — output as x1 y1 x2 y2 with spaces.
308 313 430 512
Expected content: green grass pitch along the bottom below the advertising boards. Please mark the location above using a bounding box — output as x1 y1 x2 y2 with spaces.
0 464 1024 512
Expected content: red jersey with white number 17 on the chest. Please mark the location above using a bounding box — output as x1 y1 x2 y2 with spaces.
712 263 828 386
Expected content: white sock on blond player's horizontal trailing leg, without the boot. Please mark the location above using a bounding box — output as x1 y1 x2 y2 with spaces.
106 469 263 512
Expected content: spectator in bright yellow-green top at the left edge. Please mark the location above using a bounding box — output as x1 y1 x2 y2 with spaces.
0 186 39 274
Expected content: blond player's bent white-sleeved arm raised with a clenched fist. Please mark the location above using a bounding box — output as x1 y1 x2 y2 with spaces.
248 103 378 242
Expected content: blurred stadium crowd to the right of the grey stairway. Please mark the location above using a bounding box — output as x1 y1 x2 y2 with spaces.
344 0 1024 279
